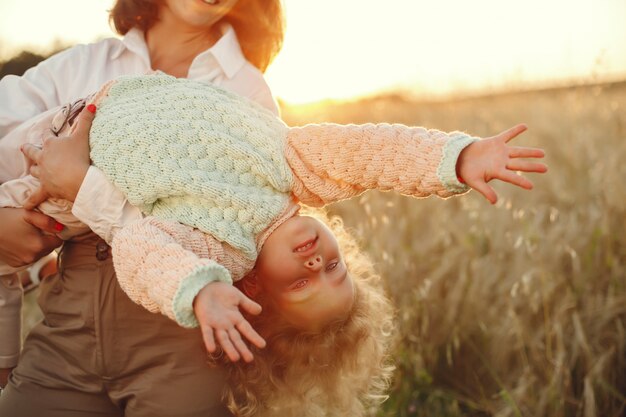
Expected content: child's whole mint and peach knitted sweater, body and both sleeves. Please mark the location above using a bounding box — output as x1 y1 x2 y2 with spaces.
90 75 478 327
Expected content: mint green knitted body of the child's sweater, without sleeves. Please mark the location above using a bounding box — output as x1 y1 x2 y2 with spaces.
90 74 292 259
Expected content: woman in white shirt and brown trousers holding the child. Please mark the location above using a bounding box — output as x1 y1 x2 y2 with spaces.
0 0 283 416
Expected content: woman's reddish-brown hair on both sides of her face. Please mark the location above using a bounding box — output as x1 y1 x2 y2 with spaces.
109 0 285 72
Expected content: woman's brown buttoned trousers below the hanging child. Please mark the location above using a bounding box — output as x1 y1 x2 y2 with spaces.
0 235 230 417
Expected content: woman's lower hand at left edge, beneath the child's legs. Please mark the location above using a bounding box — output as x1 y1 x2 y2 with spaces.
0 208 63 267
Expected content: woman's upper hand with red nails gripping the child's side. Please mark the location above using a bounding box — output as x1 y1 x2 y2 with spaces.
22 104 96 209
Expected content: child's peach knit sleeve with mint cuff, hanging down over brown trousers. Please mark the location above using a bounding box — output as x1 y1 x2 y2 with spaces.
111 217 232 327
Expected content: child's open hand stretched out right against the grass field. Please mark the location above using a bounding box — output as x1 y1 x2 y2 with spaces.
456 124 548 204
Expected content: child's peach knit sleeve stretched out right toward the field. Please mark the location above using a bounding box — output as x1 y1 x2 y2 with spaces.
285 124 478 206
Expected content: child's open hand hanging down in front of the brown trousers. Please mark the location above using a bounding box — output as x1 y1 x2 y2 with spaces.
193 282 265 362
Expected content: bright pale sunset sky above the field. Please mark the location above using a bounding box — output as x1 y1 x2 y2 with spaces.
0 0 626 103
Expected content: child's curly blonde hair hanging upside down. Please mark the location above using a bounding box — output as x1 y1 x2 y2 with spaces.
226 213 393 417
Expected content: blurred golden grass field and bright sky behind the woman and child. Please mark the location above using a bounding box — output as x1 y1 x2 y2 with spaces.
0 0 626 417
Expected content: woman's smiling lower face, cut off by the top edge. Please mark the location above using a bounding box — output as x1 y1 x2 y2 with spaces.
161 0 237 29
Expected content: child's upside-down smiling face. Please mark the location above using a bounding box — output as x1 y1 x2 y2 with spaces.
255 216 354 330
